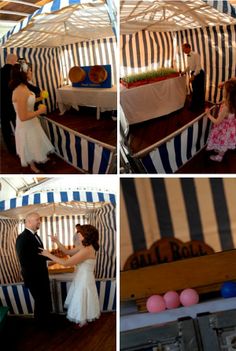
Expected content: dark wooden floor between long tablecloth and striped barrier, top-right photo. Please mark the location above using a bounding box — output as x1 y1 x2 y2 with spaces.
129 97 208 154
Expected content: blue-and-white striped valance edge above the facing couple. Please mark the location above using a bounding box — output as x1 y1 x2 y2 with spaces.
0 190 116 212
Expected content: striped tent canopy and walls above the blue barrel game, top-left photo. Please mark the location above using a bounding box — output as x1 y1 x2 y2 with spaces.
0 0 116 111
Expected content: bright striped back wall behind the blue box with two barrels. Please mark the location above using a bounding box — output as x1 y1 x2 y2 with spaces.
61 38 117 84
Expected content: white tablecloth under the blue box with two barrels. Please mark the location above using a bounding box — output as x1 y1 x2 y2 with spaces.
56 85 117 119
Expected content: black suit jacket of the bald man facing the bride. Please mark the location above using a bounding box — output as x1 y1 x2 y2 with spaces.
16 229 49 286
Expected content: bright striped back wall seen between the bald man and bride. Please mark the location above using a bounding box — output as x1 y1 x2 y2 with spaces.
15 215 88 250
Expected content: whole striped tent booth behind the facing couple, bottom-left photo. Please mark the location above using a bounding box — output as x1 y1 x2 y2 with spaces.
0 189 116 313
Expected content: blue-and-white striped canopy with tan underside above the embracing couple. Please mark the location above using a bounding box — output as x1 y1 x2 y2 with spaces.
0 190 116 218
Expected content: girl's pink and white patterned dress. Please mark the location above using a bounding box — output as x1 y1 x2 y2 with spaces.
207 105 236 152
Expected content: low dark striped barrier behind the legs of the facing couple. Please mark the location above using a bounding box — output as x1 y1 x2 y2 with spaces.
0 279 116 315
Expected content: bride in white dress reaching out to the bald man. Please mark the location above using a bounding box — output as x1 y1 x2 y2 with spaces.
40 224 100 328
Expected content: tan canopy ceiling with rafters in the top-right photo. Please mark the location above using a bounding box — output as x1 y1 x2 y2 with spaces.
120 0 236 34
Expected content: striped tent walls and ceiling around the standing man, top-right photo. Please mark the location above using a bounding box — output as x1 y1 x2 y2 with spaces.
120 0 236 102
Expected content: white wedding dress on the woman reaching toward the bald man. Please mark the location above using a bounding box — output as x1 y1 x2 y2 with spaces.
65 258 100 325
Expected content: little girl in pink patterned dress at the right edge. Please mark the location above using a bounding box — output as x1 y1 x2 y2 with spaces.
205 79 236 162
